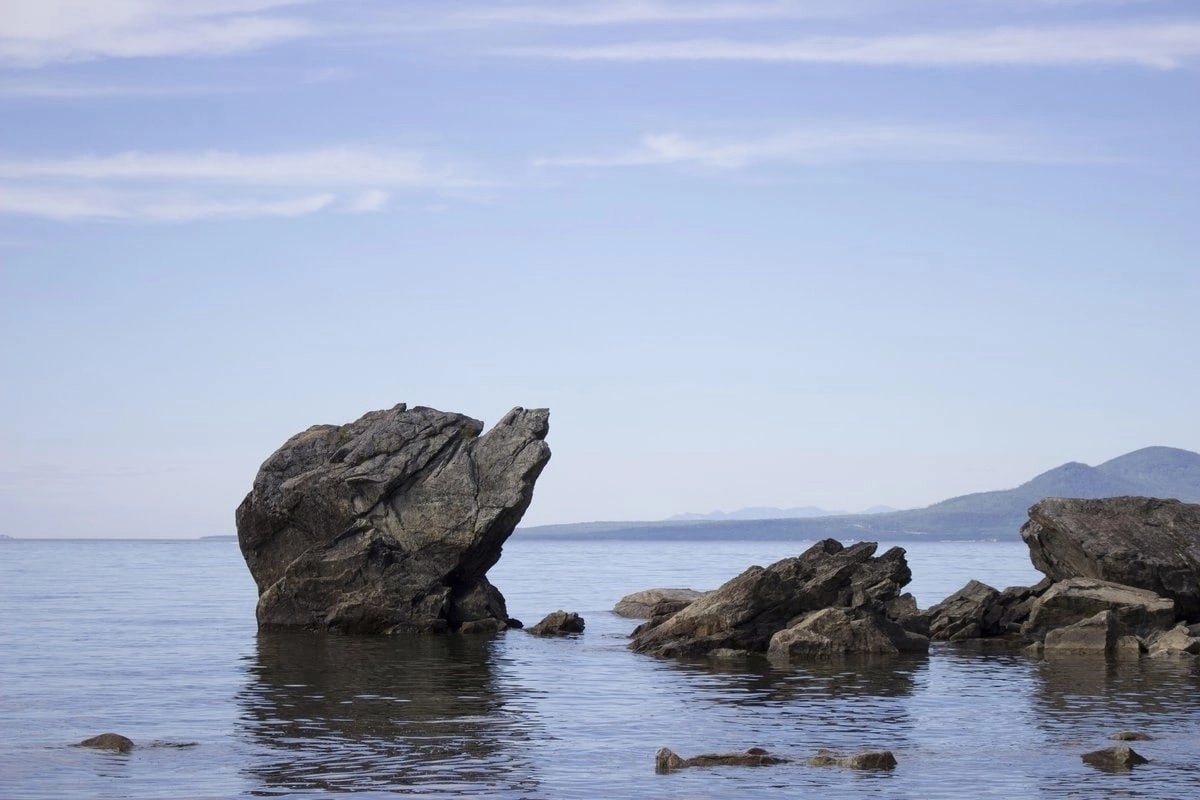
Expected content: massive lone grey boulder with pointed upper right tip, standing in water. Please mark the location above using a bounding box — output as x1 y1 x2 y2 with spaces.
236 404 550 633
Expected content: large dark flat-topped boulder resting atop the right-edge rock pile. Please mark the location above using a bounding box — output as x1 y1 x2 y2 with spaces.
1021 497 1200 621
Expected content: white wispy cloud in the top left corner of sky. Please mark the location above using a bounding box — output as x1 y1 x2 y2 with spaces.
0 0 316 67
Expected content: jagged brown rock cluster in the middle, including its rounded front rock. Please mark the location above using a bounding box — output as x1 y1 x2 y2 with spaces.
630 539 929 660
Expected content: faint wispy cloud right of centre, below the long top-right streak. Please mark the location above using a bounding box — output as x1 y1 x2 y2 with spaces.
535 124 1103 170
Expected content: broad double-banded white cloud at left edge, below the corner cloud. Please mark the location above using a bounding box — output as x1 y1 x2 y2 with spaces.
0 148 485 222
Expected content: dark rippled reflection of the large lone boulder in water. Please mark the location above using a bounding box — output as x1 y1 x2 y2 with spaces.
238 632 535 795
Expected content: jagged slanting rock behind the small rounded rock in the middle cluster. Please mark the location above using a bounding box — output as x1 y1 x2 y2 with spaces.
630 539 928 656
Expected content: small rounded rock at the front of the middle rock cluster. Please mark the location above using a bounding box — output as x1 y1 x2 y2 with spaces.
767 608 929 661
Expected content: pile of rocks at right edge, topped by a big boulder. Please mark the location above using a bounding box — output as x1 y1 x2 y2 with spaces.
926 498 1200 656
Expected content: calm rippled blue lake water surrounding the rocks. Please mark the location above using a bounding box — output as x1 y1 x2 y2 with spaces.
0 537 1200 800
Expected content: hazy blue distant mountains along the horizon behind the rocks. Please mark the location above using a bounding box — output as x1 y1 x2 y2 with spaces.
517 447 1200 541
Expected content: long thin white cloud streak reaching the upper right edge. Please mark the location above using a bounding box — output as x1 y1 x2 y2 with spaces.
494 22 1200 70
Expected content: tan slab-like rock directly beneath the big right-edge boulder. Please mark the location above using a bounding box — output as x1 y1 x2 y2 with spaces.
1025 578 1175 637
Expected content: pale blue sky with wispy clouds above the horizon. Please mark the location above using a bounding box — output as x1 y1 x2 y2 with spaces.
0 0 1200 537
